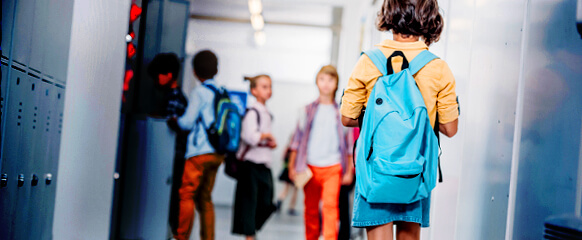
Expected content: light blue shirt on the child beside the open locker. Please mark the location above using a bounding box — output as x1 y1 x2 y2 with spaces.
178 79 216 159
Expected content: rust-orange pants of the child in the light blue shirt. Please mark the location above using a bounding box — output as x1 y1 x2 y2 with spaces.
174 154 224 240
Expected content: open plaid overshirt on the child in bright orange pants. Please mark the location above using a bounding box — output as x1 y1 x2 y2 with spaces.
289 99 353 173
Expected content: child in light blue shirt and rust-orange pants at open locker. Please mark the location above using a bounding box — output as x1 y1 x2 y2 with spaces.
174 50 224 240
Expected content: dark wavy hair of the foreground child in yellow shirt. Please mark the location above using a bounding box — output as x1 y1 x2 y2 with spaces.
376 0 444 45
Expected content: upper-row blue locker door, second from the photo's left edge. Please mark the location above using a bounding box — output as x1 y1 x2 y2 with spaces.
12 0 36 66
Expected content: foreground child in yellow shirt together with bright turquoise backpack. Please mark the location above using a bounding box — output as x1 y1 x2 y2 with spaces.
341 0 459 240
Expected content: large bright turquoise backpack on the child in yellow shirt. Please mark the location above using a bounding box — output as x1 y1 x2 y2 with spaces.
356 49 439 204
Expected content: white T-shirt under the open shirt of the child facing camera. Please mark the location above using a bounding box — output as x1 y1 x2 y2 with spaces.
307 104 341 167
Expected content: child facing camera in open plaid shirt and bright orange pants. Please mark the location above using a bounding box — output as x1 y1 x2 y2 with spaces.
289 65 354 240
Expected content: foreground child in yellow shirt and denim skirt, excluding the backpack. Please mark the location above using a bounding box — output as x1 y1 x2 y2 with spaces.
341 0 459 240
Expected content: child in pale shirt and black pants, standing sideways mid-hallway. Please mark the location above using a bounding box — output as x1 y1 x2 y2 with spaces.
232 75 277 240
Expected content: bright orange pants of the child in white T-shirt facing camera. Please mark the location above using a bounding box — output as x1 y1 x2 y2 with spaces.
303 164 342 240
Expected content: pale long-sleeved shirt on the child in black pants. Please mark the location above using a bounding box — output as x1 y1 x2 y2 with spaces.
237 102 273 166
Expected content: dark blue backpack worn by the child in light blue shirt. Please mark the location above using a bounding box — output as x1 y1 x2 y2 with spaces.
200 84 241 154
